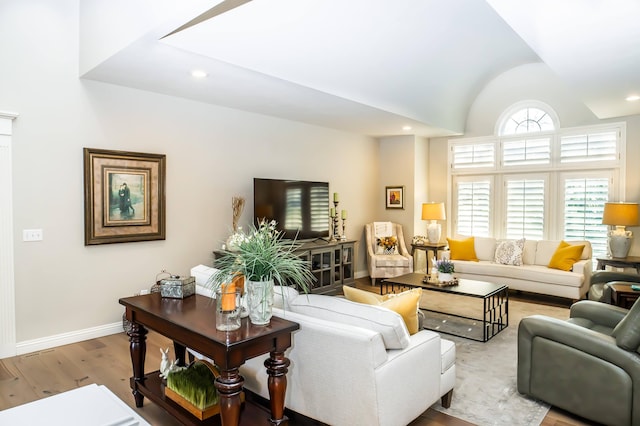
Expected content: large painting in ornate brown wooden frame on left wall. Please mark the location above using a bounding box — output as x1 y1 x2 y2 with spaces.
84 148 166 246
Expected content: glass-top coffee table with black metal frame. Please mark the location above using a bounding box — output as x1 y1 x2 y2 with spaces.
380 274 509 342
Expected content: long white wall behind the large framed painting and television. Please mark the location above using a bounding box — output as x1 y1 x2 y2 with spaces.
0 0 380 344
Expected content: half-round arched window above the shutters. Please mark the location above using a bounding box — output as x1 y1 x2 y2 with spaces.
496 101 559 136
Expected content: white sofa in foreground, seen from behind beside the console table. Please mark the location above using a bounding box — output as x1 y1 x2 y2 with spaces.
189 265 456 426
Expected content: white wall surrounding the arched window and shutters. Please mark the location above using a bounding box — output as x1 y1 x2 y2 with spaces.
429 63 640 251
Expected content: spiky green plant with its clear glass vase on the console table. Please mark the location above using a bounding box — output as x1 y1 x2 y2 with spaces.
209 220 315 325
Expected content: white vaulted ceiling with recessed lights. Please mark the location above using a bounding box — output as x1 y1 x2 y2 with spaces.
80 0 640 137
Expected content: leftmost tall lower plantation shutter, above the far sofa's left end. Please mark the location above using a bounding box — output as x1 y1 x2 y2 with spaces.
456 180 491 237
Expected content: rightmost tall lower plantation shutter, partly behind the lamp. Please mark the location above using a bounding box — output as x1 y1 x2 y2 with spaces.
564 177 610 255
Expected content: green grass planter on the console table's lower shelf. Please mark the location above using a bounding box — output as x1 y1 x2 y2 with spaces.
167 362 218 410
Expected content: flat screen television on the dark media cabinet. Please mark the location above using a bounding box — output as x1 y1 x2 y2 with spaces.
253 178 329 240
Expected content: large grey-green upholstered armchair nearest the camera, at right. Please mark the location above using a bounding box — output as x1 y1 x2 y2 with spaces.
518 300 640 426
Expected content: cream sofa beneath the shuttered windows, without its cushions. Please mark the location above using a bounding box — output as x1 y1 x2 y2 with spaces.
444 237 593 300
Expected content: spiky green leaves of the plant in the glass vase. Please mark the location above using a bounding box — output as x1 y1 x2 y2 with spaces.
209 221 315 293
